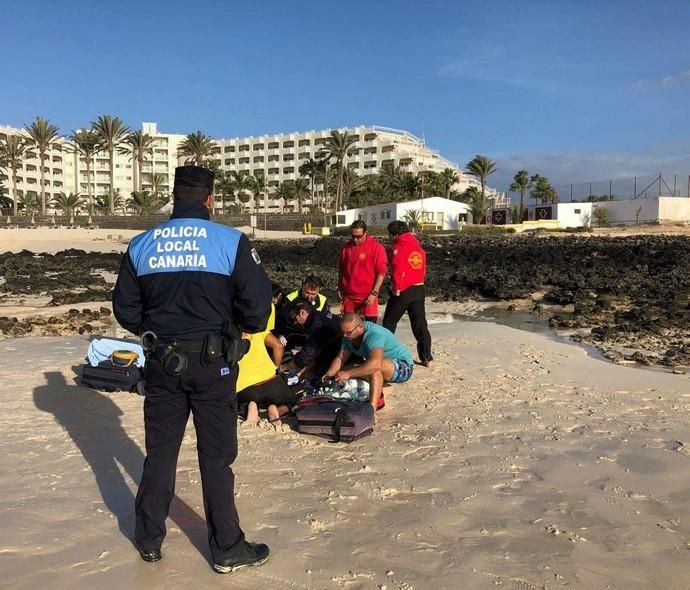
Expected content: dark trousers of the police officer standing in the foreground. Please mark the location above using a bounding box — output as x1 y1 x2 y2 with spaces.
135 353 244 563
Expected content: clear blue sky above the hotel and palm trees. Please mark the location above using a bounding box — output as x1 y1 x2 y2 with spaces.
0 0 690 188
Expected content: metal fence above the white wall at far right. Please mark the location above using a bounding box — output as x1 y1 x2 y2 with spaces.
554 174 690 203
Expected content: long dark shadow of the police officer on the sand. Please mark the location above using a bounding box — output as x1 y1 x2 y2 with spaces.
34 372 210 559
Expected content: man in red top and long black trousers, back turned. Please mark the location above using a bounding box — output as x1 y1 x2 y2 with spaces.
383 221 433 367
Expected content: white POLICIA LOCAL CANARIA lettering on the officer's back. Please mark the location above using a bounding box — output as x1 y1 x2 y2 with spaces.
148 225 208 270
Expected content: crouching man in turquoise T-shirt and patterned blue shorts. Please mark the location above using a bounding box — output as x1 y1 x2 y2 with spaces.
326 313 413 410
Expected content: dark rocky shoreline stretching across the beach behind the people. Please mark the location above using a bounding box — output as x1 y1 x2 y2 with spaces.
0 234 690 370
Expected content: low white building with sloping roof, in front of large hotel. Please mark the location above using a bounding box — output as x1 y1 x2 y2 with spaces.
328 197 472 230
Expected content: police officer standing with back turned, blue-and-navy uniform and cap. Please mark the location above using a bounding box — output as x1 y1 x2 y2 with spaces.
113 166 271 573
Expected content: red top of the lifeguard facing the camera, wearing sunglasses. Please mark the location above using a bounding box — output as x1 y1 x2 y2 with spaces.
338 236 388 299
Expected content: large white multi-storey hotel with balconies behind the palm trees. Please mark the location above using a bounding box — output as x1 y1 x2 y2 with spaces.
0 123 495 211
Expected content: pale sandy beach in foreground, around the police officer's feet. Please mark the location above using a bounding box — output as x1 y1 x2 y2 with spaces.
0 230 690 590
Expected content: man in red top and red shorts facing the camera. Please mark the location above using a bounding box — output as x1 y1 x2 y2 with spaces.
338 219 388 322
